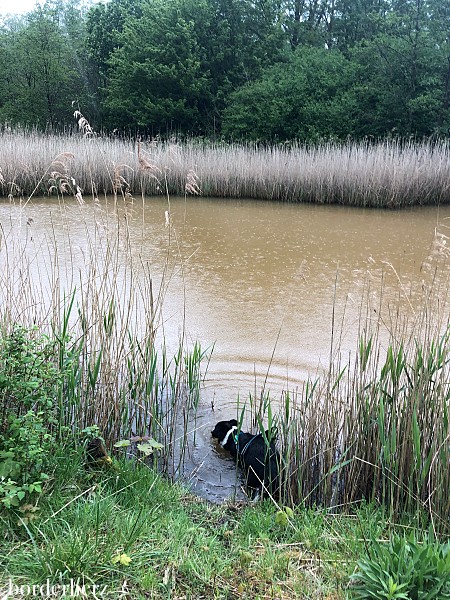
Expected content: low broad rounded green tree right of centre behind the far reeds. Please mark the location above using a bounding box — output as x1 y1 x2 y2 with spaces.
224 48 356 141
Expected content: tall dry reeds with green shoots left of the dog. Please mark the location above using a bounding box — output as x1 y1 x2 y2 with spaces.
0 186 205 476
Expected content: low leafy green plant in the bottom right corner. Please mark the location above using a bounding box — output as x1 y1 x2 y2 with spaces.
351 534 450 600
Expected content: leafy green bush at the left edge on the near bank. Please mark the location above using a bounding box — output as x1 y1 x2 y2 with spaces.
0 326 62 508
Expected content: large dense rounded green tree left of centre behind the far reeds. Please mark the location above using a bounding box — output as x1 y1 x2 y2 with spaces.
105 0 208 132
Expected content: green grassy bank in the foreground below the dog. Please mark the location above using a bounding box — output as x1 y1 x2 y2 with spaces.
0 451 394 600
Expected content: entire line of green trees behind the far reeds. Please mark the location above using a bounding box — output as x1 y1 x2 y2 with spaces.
0 0 450 142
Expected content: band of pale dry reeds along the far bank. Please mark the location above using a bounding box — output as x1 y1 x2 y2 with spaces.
0 131 450 208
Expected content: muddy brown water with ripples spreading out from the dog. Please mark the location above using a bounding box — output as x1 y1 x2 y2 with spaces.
0 198 450 501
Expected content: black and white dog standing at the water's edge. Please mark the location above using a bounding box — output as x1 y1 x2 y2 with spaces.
211 419 280 498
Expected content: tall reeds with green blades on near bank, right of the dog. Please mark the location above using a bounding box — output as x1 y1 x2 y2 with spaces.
248 265 450 533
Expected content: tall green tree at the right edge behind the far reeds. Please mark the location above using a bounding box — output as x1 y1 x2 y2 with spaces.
350 0 448 136
